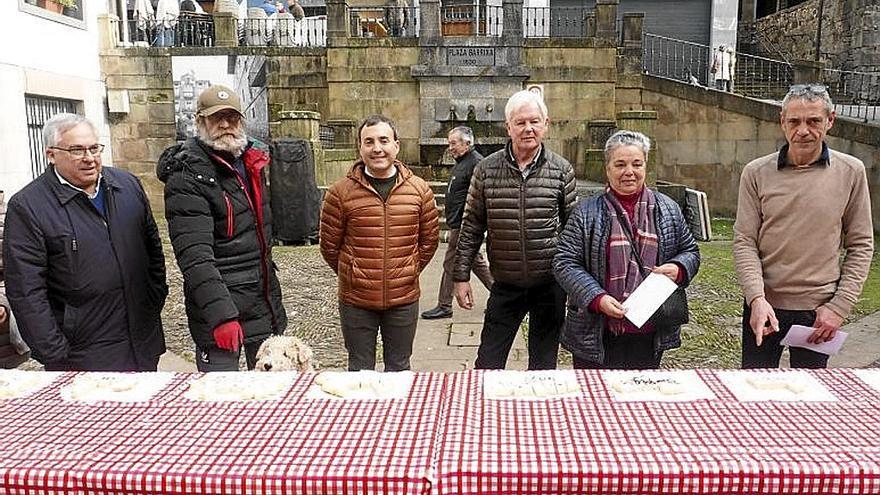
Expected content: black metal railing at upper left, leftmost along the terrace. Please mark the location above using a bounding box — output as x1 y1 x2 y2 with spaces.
120 12 214 47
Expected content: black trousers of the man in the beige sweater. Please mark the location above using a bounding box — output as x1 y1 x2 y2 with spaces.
742 304 828 369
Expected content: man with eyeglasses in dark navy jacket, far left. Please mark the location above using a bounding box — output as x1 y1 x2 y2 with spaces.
3 113 168 371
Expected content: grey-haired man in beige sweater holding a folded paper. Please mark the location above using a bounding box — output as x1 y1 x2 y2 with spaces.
733 84 874 368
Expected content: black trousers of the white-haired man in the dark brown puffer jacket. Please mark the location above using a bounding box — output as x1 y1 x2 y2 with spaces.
474 280 565 370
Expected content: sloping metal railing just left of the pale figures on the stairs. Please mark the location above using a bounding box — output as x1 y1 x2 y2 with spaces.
642 33 711 86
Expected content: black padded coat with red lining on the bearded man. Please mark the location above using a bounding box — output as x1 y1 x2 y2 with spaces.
156 138 287 348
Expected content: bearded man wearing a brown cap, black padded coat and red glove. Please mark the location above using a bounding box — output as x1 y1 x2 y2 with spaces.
156 85 287 371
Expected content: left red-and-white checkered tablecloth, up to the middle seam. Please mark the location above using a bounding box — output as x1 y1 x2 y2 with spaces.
0 373 445 495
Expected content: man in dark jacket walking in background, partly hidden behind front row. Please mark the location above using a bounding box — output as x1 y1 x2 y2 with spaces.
422 126 492 320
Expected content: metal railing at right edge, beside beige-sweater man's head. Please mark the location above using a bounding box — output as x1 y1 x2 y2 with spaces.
821 69 880 122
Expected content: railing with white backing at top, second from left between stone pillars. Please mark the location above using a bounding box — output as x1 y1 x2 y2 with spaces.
239 14 327 46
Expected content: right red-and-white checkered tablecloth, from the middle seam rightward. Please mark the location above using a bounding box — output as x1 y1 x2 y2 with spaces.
435 370 880 494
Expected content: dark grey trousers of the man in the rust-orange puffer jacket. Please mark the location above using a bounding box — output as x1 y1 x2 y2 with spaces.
339 301 419 371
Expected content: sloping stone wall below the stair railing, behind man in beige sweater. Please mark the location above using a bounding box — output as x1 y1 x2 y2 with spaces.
641 76 880 228
